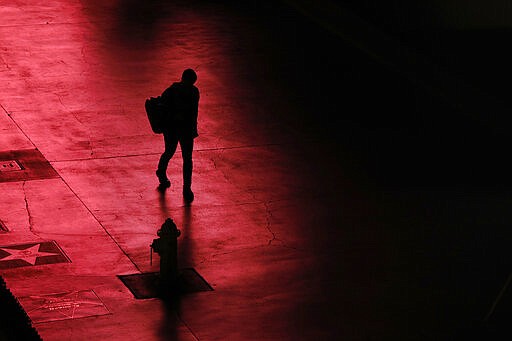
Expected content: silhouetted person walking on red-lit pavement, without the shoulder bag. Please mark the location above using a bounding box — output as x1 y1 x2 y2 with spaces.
156 69 199 202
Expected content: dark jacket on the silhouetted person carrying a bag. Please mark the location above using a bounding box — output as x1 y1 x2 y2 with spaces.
162 82 199 138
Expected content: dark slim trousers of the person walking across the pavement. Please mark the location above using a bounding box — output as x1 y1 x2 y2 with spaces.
157 133 194 188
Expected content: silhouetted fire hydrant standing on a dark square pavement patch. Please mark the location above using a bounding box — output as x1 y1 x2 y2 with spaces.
150 218 181 292
